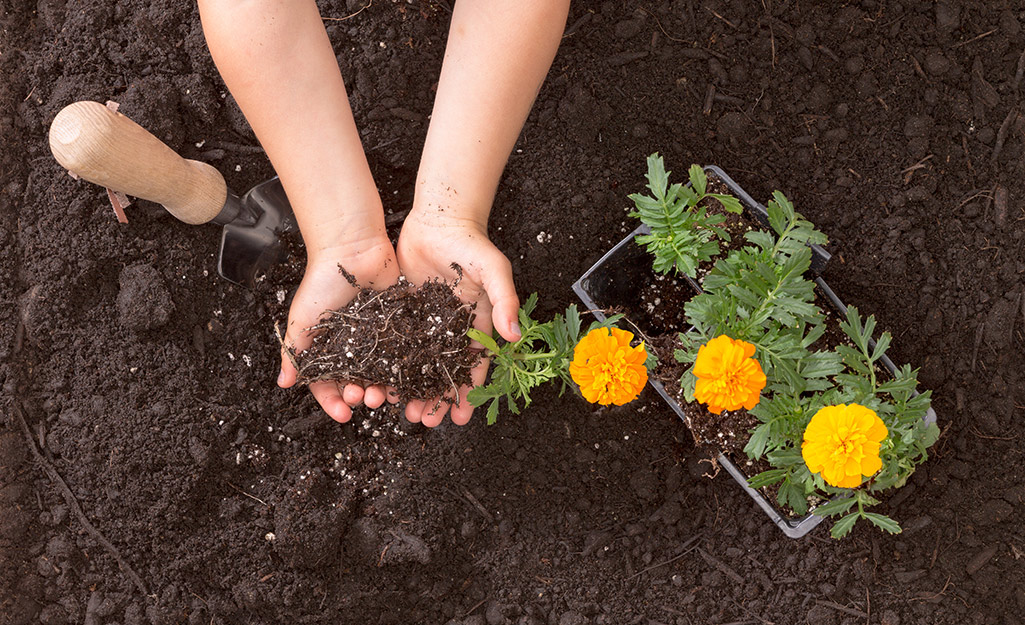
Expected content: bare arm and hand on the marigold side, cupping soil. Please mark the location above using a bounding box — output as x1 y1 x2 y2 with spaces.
399 0 569 426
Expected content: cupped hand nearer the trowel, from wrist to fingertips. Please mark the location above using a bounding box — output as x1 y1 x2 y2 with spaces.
278 238 399 423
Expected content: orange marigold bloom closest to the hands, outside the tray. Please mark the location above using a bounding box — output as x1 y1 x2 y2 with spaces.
570 328 648 406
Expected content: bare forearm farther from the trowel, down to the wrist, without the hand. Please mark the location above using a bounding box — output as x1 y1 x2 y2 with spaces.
416 0 569 227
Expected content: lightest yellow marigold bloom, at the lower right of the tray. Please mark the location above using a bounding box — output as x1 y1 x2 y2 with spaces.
801 404 889 489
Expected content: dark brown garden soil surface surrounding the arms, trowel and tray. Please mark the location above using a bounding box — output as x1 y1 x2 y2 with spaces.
0 0 1025 625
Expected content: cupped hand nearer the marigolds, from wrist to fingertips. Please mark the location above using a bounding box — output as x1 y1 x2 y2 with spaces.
398 208 520 427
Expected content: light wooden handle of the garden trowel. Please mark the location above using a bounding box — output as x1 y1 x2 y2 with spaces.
50 101 228 223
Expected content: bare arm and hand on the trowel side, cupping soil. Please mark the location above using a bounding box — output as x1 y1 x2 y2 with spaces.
199 0 398 421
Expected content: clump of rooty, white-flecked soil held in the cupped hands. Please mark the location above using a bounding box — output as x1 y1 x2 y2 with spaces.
290 272 480 400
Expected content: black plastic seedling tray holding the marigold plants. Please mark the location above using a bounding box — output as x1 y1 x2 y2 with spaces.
573 167 936 538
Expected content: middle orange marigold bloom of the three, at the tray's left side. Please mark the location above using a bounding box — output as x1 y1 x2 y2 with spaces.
691 334 766 415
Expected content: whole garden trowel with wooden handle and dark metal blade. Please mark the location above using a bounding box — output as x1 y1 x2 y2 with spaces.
50 101 296 287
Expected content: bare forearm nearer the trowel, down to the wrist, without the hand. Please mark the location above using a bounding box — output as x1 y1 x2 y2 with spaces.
199 0 385 258
